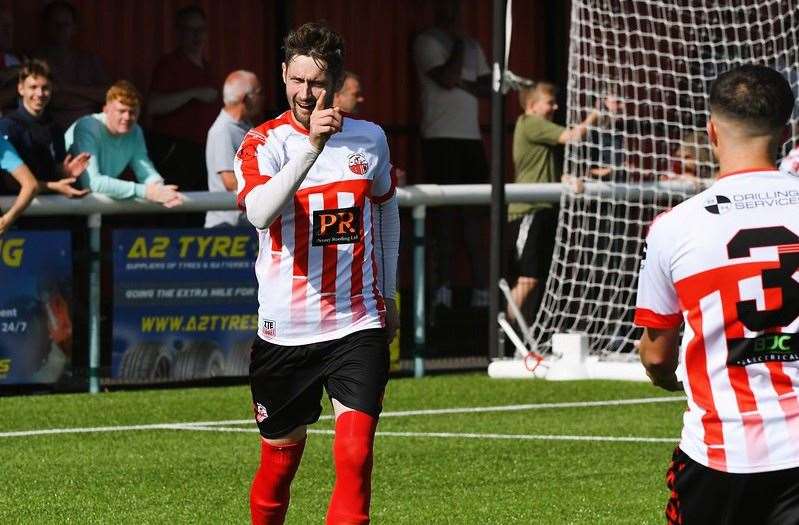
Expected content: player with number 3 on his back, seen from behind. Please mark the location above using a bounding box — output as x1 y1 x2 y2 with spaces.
635 66 799 525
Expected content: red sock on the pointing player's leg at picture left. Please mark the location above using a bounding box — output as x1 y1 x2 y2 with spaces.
250 439 305 525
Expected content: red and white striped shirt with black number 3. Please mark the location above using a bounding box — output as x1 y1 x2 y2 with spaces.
635 169 799 473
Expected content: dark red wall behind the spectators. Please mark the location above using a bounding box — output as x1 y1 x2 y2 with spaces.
0 0 554 182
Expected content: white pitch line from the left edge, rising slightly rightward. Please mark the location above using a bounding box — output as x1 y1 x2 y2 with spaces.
0 396 685 438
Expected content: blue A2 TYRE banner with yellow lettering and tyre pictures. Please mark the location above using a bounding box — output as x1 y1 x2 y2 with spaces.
111 228 258 382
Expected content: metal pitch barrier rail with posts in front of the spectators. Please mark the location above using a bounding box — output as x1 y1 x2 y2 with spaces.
0 183 691 392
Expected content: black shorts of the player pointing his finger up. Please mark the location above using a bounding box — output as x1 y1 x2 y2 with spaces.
250 328 389 439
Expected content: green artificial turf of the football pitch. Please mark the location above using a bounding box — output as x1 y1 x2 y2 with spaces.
0 374 684 524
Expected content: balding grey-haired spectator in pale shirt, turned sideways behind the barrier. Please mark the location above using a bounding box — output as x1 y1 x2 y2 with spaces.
205 70 263 228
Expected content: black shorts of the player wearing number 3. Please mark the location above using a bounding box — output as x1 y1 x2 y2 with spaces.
666 447 799 525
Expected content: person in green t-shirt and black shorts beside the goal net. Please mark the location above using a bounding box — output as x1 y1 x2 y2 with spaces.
508 81 618 319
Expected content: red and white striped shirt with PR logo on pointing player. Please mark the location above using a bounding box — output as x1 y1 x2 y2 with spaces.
234 111 395 346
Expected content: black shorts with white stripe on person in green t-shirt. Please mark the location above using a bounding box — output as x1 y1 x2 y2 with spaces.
508 208 558 279
